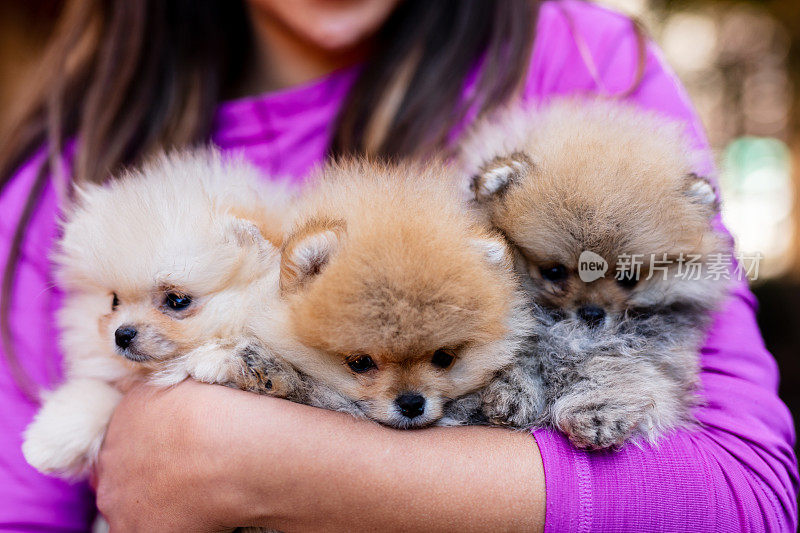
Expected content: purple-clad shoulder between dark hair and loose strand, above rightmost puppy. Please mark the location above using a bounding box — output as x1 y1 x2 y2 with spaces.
525 0 646 98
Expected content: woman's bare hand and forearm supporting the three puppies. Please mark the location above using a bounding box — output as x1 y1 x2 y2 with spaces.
92 382 544 531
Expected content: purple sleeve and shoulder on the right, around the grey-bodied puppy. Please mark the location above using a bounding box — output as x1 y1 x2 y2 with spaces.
525 1 798 532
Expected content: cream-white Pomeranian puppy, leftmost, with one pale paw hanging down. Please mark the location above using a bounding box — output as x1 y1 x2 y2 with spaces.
23 150 306 477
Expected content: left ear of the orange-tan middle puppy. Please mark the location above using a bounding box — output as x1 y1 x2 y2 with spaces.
281 221 344 291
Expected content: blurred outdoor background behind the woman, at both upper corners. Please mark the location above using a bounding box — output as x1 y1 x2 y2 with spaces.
0 0 800 432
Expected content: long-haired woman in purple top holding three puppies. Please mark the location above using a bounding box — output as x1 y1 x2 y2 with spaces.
0 0 798 531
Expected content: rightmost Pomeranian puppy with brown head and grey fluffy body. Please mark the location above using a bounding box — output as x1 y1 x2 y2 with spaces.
461 101 731 448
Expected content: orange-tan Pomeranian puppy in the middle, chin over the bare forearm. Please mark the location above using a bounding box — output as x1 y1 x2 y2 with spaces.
244 160 532 428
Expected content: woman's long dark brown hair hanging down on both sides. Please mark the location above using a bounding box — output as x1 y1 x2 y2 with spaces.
0 0 539 398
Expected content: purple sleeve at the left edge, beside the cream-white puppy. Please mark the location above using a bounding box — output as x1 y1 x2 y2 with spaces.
0 148 95 532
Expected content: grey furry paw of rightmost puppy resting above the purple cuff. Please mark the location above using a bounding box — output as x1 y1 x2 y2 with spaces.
556 403 639 450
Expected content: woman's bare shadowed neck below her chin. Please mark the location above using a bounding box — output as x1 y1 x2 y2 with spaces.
234 5 371 96
